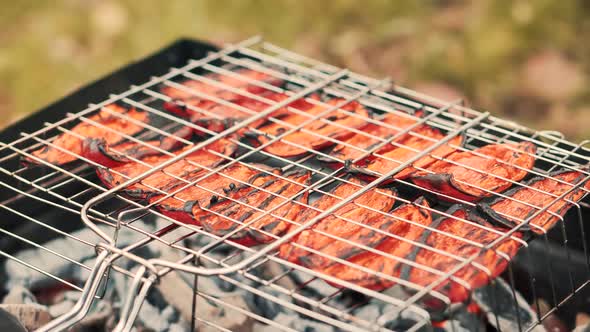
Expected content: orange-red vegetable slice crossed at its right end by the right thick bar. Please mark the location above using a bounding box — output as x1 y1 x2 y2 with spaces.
349 126 463 179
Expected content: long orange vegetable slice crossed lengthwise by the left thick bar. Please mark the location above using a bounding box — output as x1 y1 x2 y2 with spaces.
97 139 237 198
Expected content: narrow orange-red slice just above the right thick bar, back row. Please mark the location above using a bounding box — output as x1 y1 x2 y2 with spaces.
318 113 421 164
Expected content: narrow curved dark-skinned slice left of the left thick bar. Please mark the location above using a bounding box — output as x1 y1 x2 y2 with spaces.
81 127 192 168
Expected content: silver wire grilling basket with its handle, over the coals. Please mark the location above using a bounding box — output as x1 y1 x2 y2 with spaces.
0 38 590 330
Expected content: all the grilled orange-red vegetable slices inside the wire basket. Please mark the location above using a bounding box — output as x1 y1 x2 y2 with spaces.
23 70 590 302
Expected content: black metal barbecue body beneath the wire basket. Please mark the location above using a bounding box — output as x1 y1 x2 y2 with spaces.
0 39 590 328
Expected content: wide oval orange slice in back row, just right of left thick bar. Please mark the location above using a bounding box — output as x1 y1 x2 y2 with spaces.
249 99 369 158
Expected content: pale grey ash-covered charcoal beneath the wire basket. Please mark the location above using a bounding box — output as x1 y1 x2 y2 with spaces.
3 217 536 332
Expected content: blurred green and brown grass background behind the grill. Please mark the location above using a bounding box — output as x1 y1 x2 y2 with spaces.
0 0 590 140
